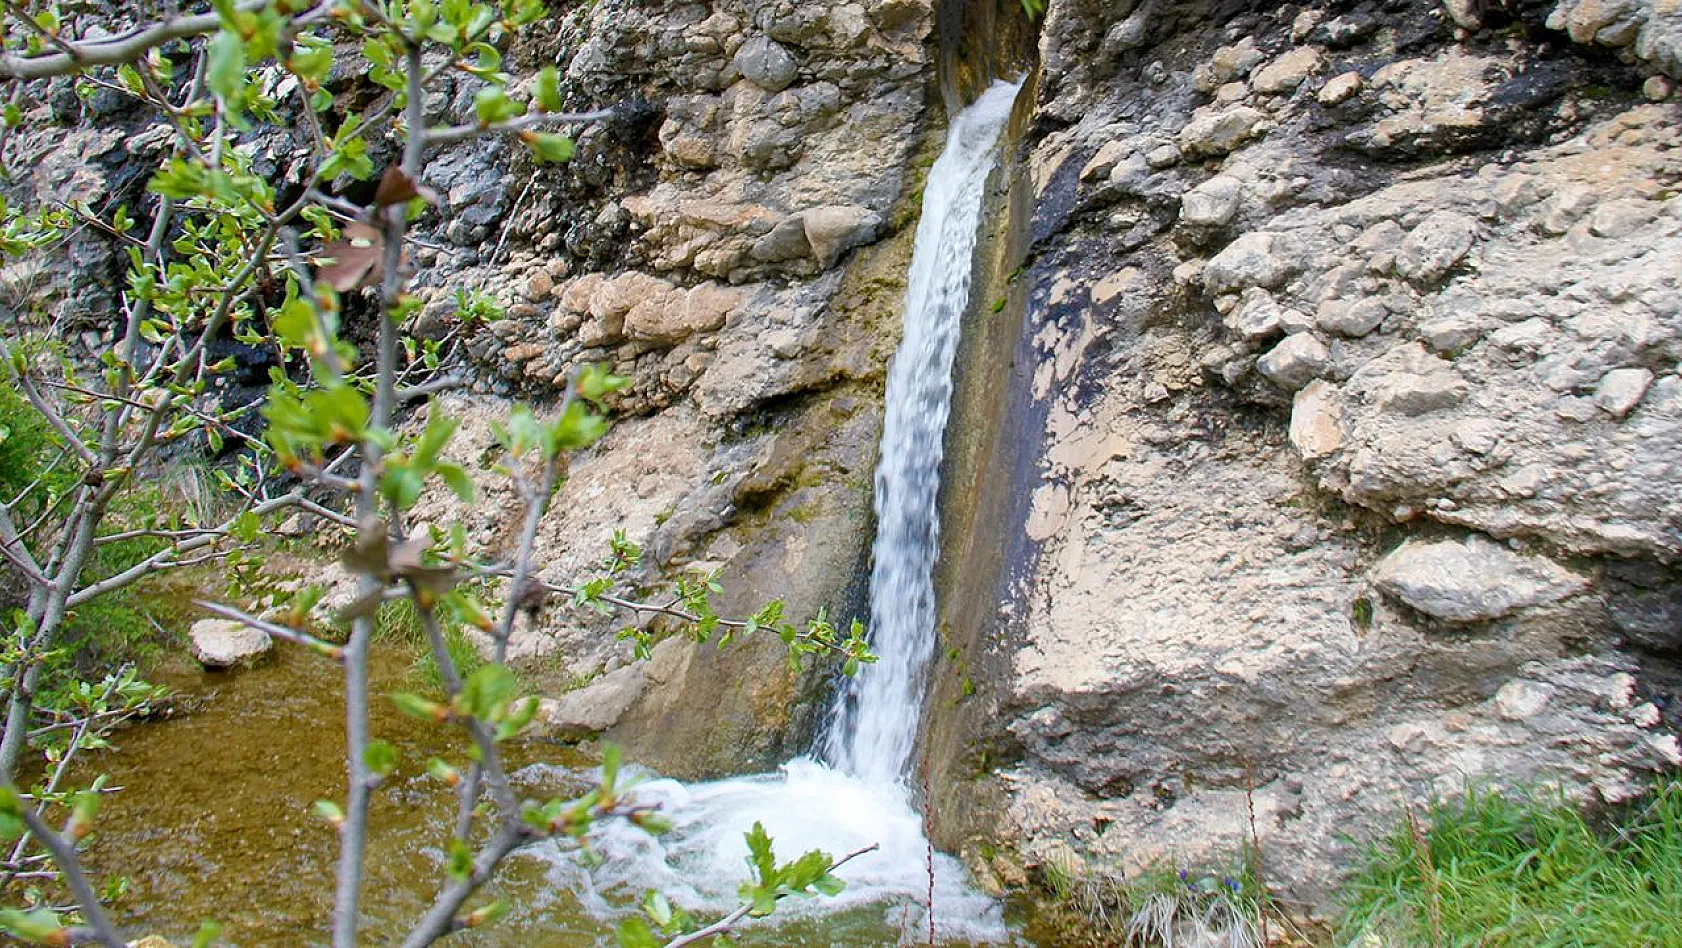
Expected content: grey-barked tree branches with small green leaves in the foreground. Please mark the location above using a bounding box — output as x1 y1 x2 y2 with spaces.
0 0 873 948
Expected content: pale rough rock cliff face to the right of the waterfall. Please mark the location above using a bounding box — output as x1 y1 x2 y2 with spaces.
930 0 1682 904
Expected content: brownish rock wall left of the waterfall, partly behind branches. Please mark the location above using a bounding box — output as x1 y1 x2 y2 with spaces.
0 0 942 777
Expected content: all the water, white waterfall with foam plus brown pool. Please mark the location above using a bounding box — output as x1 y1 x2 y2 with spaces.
72 82 1018 948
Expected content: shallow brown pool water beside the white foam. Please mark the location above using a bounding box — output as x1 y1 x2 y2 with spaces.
62 644 962 948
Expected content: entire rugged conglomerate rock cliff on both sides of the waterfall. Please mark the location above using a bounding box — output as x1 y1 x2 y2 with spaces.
0 0 1682 927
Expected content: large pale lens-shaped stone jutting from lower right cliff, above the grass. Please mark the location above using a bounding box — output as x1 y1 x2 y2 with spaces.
1373 535 1588 622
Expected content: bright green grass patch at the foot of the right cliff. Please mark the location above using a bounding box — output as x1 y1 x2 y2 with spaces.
1341 777 1682 948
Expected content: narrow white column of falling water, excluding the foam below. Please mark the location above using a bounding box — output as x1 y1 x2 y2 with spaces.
826 82 1018 783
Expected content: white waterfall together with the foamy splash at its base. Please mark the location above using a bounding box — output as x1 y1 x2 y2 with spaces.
557 82 1019 943
